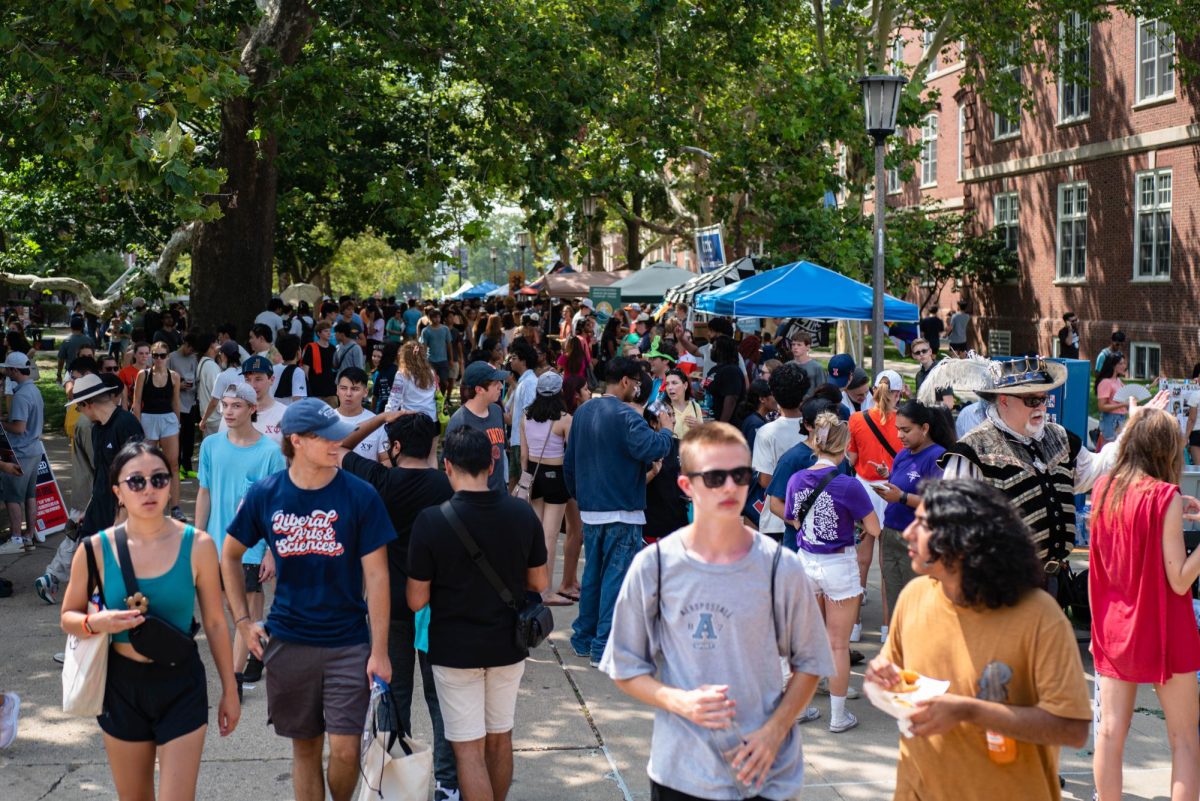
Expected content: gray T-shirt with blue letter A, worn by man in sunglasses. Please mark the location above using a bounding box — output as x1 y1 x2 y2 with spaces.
600 534 834 799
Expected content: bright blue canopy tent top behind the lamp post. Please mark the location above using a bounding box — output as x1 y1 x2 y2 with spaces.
696 261 919 323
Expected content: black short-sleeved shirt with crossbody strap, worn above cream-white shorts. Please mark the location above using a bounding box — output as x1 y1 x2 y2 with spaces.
408 492 546 668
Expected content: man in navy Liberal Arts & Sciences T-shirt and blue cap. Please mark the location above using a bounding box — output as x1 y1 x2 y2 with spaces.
221 398 396 801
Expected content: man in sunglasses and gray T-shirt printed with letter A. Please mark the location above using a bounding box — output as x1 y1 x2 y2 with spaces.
600 423 833 801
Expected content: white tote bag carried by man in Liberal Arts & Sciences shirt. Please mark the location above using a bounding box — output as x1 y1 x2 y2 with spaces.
358 679 433 801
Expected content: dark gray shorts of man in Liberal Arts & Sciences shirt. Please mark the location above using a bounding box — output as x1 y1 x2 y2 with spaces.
263 637 371 740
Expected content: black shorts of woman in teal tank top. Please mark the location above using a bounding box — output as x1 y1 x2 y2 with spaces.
96 650 209 746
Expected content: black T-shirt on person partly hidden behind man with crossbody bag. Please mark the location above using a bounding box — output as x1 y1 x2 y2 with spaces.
342 452 454 620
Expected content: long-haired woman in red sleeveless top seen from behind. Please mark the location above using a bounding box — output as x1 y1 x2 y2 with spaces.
1088 407 1200 801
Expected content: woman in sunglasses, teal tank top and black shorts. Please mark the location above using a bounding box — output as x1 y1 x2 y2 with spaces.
61 441 241 800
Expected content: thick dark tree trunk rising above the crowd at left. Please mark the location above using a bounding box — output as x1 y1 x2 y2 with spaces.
184 0 313 333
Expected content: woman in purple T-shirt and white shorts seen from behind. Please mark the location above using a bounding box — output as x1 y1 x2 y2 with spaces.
784 411 880 734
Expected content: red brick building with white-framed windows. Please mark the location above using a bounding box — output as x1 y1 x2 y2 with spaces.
887 11 1200 378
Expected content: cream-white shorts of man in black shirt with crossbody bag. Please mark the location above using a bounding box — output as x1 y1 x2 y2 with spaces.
433 661 524 742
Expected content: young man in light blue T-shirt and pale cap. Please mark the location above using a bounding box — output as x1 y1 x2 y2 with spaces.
196 383 288 689
